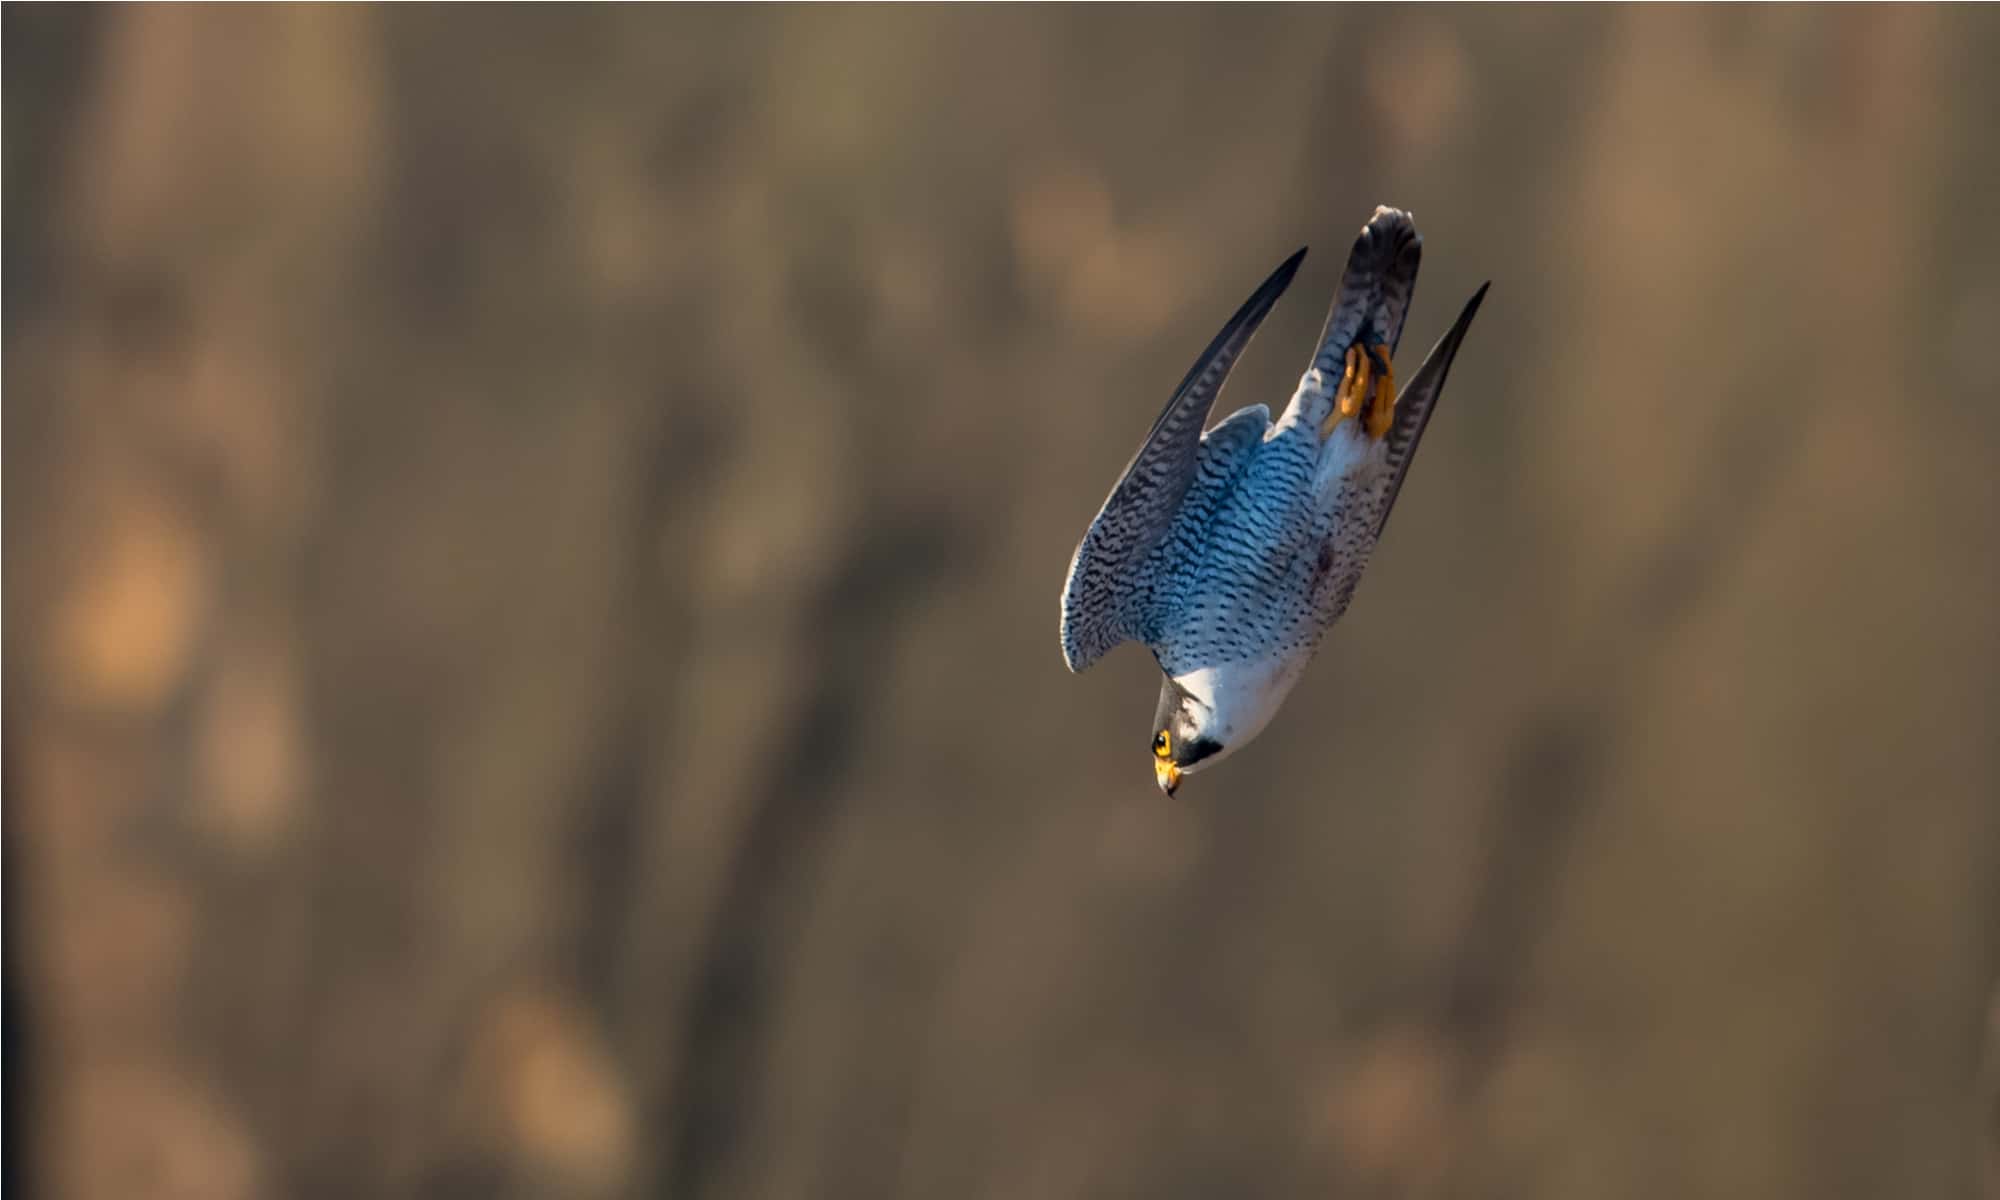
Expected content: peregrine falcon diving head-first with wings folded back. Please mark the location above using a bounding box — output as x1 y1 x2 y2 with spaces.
1062 208 1486 796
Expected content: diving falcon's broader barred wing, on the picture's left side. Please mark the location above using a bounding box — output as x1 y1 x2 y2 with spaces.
1062 250 1306 670
